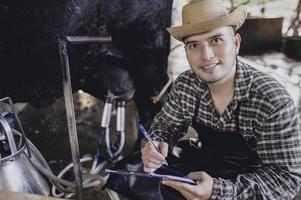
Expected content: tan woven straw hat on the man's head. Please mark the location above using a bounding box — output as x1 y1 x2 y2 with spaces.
167 0 247 41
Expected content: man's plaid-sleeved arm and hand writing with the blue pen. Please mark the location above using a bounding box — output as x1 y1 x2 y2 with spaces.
141 75 188 172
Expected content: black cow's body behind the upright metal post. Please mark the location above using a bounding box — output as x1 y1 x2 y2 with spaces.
0 0 172 129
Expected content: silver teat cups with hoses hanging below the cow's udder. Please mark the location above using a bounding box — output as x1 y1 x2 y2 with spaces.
52 93 125 199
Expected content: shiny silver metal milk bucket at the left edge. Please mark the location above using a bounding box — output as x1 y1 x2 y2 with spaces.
0 113 50 196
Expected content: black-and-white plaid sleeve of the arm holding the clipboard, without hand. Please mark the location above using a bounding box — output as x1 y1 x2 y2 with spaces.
211 99 301 200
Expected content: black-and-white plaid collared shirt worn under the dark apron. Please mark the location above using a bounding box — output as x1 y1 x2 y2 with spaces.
150 60 301 200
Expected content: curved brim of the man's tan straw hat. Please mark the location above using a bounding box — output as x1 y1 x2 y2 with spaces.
167 5 247 41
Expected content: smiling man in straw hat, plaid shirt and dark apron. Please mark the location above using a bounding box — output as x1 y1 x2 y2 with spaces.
141 0 301 200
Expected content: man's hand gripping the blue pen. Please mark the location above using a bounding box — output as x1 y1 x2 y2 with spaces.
141 142 168 172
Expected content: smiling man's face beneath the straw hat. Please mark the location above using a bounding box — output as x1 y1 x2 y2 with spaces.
184 26 240 83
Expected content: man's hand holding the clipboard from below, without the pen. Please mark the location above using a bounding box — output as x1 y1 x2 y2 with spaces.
162 171 213 200
